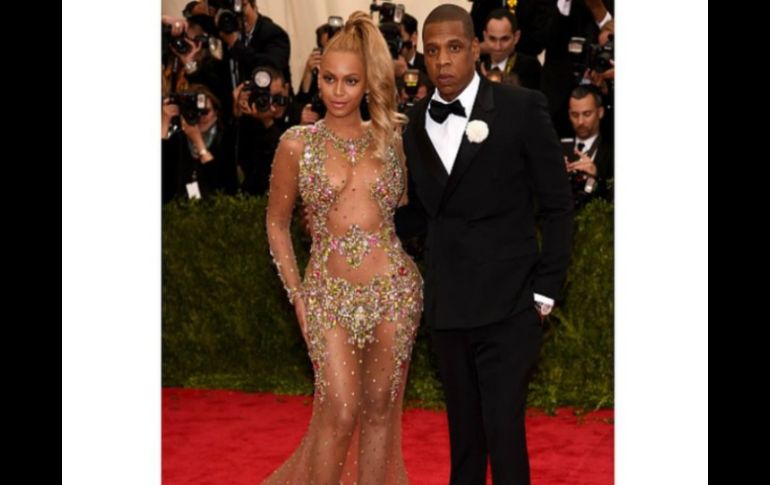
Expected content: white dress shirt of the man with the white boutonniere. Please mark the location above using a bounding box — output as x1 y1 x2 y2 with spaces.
425 73 481 173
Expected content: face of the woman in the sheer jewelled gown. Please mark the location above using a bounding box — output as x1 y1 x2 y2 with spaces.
318 51 366 118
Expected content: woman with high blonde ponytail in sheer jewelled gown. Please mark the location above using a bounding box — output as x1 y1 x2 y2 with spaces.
265 12 423 485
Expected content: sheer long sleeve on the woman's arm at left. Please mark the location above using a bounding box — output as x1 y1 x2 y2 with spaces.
266 130 302 303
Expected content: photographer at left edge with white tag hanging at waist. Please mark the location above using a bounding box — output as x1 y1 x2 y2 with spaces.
161 85 237 203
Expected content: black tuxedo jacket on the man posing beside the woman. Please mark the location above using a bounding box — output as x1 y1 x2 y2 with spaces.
397 79 572 329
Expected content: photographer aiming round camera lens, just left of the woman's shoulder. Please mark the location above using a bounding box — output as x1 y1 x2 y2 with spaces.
233 67 300 195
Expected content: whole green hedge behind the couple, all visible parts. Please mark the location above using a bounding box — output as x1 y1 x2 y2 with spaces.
162 196 613 409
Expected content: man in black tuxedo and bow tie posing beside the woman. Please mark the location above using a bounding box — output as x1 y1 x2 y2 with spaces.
397 5 572 485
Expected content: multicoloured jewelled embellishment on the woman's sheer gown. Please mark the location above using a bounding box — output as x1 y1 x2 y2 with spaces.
284 125 423 401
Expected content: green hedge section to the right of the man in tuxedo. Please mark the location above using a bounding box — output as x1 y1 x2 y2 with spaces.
529 199 614 410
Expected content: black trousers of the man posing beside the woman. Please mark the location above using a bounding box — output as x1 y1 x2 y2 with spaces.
431 308 543 485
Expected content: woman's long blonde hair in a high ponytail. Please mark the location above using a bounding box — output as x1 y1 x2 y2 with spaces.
324 11 406 160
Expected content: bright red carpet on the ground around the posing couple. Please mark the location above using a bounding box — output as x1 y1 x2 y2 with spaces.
162 389 614 485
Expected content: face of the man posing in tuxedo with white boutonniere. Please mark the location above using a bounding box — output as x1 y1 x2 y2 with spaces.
422 20 479 101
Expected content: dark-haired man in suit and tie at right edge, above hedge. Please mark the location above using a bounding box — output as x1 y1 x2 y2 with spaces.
562 86 614 206
